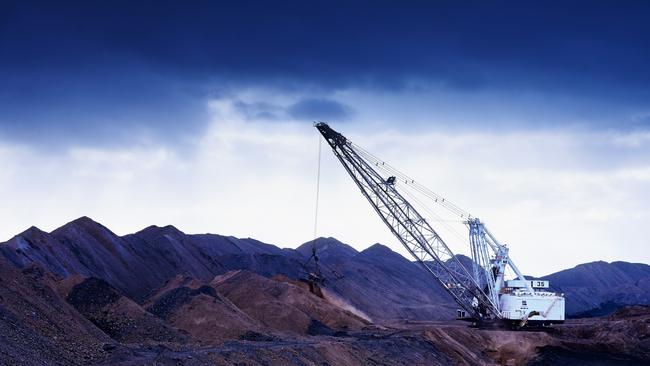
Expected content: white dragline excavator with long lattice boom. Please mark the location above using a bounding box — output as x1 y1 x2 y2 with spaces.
314 122 564 328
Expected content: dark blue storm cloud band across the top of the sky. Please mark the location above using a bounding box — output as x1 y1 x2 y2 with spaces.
0 1 650 146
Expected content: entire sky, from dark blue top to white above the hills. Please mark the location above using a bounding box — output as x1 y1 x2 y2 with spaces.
0 1 650 274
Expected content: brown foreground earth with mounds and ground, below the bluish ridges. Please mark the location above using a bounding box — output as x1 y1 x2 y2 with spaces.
0 265 650 365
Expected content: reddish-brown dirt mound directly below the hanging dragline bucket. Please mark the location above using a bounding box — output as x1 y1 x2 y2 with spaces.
211 271 368 335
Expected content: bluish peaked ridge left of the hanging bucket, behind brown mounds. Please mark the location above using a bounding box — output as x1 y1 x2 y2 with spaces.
0 217 304 302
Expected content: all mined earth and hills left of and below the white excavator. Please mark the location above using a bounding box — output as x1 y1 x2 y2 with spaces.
0 218 650 365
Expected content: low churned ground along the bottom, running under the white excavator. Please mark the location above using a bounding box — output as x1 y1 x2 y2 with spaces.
96 308 650 365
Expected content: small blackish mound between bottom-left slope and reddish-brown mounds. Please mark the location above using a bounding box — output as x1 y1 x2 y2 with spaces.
67 278 186 343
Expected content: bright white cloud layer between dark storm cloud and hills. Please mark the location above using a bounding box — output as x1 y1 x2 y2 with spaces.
0 99 650 275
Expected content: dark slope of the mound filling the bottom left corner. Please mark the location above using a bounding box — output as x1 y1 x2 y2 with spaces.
0 259 111 365
